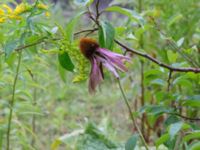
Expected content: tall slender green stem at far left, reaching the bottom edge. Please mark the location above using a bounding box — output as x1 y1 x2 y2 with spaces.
6 51 22 150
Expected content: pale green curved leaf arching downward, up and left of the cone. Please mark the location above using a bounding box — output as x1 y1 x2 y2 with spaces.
66 12 84 42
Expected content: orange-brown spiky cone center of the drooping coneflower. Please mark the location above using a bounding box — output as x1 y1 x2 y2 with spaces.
79 38 99 59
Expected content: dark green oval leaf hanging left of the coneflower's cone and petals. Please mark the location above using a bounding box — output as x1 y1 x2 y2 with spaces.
58 51 74 71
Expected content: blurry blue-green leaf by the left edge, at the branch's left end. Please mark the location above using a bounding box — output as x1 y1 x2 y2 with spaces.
4 40 18 58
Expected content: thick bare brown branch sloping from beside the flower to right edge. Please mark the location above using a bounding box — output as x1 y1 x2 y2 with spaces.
115 40 200 73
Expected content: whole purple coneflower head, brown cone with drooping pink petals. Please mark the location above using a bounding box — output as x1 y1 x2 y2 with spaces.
80 38 130 93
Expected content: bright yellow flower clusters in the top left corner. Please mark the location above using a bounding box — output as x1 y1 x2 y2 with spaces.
0 3 50 23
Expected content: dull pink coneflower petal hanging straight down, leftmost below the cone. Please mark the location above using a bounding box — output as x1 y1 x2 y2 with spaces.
89 57 103 93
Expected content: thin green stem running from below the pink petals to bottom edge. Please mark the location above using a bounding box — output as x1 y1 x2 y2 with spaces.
117 78 149 150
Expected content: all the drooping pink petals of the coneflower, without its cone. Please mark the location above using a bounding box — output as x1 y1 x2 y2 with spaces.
89 48 131 93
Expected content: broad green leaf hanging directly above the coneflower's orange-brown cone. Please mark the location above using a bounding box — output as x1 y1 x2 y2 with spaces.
99 22 115 50
